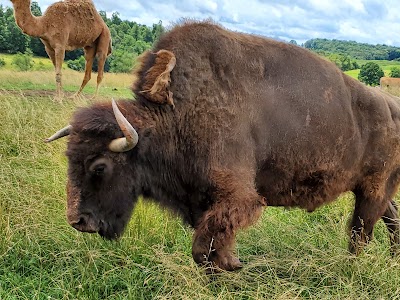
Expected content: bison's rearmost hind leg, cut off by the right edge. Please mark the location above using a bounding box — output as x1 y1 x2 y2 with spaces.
382 200 400 255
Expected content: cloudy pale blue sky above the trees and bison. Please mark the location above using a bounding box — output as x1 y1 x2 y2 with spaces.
0 0 400 47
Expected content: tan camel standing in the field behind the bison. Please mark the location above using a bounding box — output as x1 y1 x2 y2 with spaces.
10 0 112 101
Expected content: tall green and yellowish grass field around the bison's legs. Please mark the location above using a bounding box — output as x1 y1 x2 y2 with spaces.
0 71 400 300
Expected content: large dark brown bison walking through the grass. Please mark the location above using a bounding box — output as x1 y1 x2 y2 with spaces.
48 22 400 270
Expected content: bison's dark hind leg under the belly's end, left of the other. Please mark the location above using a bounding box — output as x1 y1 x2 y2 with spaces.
349 191 387 255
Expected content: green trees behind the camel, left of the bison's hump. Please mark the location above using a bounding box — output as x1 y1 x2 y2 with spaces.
0 2 164 73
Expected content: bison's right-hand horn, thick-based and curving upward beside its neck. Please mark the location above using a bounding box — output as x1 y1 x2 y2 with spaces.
108 99 139 152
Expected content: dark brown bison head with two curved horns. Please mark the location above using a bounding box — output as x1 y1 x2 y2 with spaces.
46 100 138 239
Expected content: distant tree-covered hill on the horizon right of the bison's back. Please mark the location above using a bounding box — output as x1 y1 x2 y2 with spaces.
304 39 400 60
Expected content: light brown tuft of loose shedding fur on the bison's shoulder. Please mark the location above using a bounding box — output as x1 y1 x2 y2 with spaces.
140 50 176 106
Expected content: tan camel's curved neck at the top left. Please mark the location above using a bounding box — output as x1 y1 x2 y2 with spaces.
13 0 42 37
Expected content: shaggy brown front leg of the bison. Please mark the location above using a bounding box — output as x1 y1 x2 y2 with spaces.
192 171 265 271
